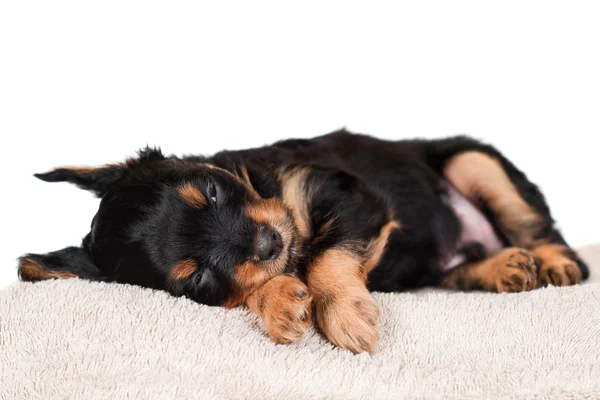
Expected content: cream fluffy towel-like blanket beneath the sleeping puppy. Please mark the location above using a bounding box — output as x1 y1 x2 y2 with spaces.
0 244 600 399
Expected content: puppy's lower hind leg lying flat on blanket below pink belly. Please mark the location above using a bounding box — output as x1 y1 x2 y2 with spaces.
439 247 537 292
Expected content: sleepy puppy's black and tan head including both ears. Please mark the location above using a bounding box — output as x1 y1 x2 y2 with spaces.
19 149 298 306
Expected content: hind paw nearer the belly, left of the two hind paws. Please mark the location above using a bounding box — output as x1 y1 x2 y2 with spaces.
496 248 537 292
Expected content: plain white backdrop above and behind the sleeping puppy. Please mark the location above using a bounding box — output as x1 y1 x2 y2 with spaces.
0 0 600 286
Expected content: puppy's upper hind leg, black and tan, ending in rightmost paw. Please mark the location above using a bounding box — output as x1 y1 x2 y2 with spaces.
432 138 589 286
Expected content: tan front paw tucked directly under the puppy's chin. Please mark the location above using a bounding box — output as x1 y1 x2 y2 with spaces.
248 275 312 344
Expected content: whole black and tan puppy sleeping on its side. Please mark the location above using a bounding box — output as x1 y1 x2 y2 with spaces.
19 131 588 352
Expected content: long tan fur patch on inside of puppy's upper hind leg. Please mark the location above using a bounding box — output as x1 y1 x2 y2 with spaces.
444 151 545 248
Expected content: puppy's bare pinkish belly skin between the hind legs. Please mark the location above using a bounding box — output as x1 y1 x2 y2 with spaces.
441 184 503 271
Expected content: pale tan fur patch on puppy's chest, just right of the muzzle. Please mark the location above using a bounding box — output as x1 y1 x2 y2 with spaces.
280 168 313 239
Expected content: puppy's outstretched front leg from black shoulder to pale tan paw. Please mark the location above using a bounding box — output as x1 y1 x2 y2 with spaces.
281 168 399 353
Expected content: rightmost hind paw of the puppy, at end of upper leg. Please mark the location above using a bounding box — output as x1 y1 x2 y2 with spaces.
533 244 581 286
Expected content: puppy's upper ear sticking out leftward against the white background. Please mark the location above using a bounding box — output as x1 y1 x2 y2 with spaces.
34 147 165 197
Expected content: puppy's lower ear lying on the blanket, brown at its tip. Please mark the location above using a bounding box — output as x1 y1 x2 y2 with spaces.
19 247 107 281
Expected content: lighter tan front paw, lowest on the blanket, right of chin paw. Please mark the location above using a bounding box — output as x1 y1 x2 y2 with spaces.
315 287 379 354
